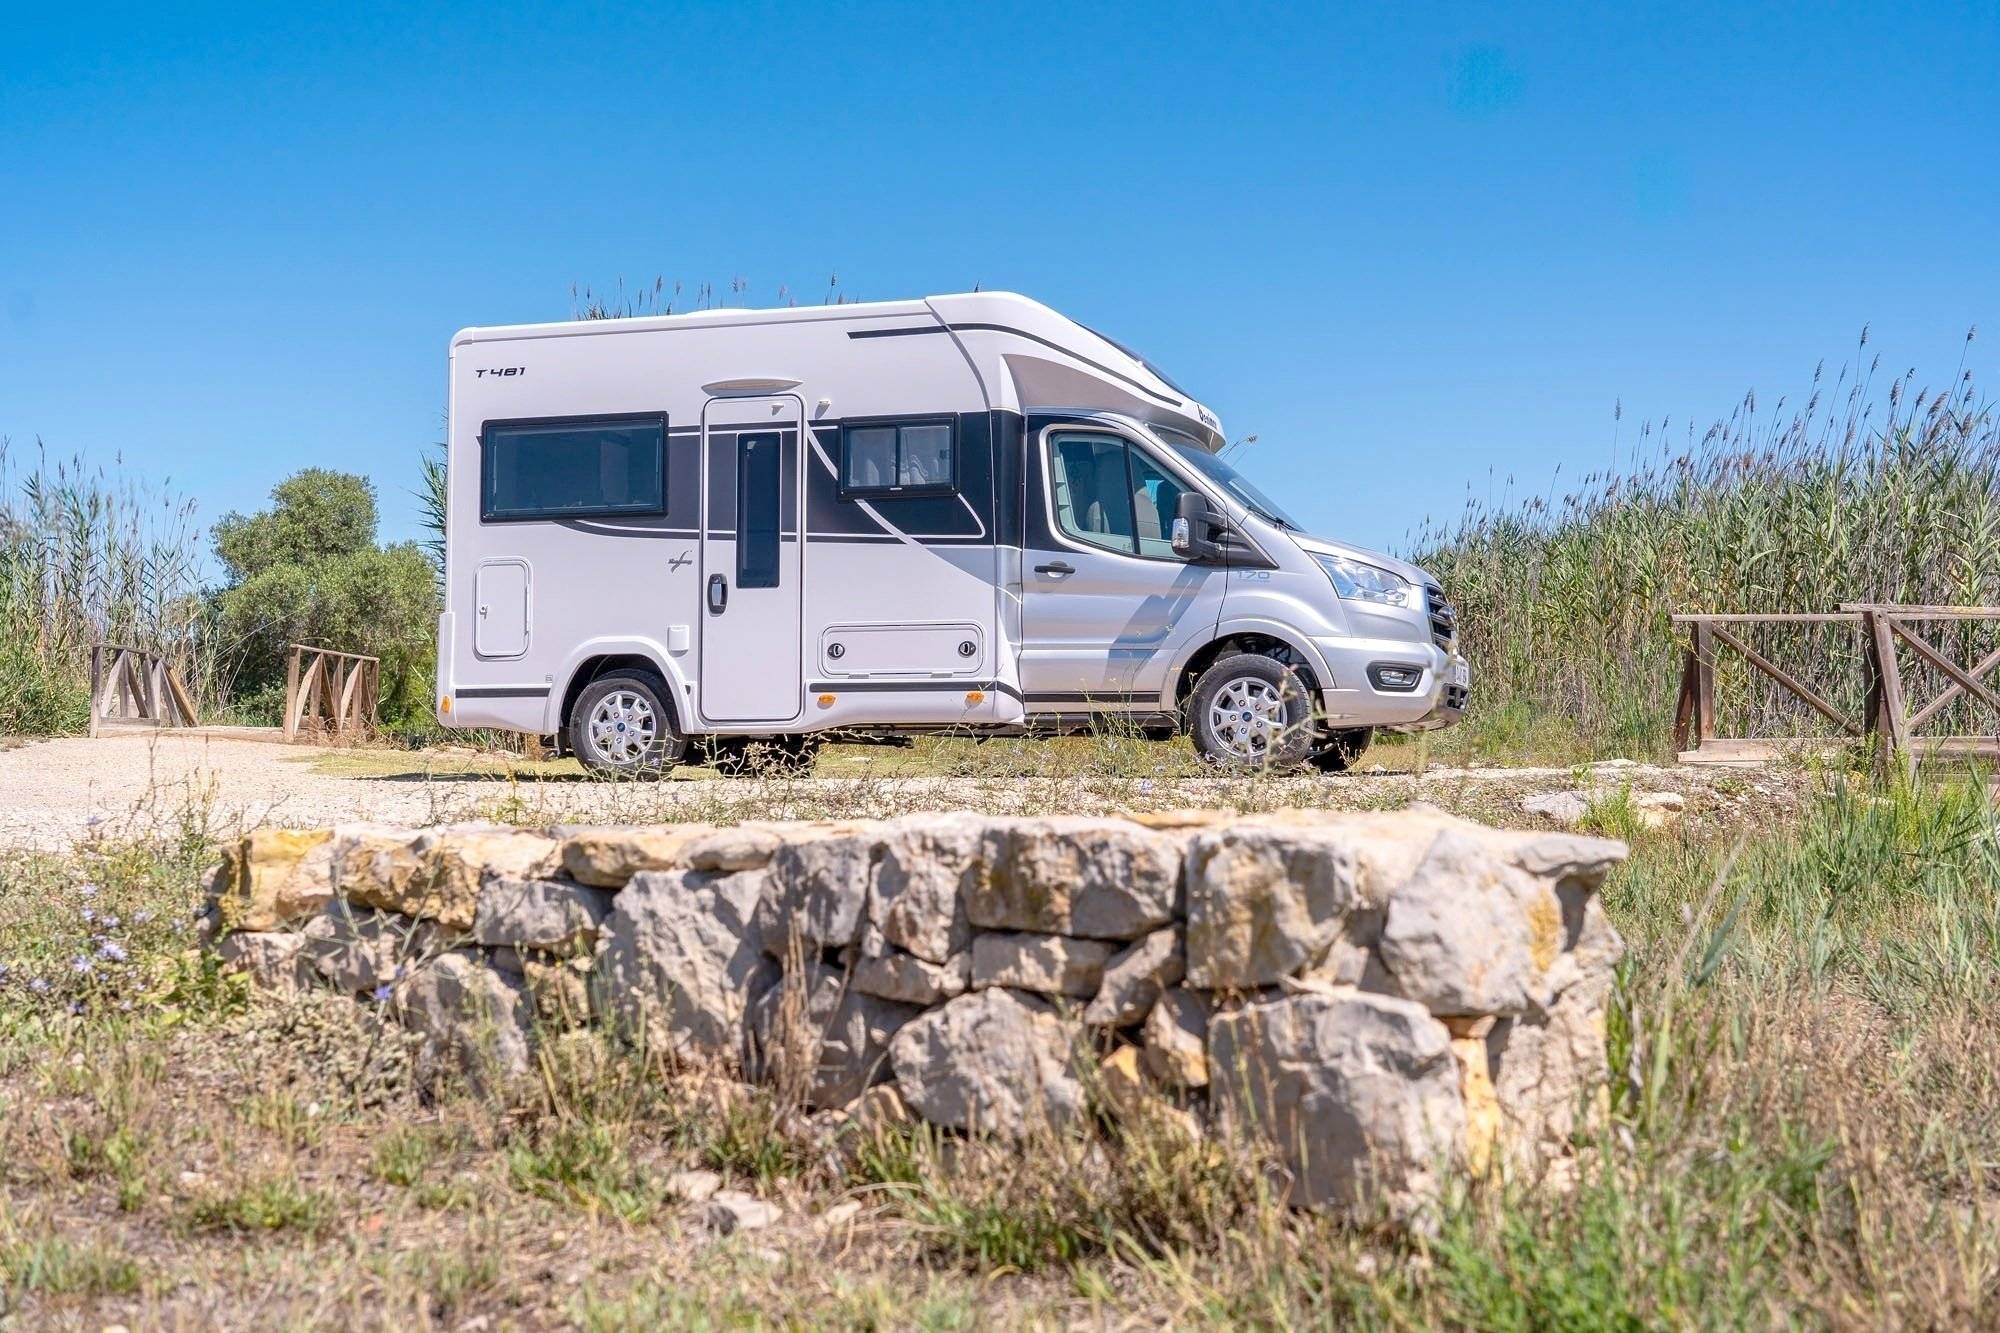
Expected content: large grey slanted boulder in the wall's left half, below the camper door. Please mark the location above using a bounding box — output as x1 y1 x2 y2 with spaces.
592 871 778 1063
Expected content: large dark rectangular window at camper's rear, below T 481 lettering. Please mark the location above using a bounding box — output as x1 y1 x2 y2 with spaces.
480 416 666 518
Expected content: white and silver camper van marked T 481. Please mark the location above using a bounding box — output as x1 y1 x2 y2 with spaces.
438 292 1468 775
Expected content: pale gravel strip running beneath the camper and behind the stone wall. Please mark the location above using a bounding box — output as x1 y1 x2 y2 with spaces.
0 733 1802 851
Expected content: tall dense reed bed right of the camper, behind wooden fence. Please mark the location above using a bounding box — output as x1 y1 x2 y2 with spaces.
1410 330 2000 759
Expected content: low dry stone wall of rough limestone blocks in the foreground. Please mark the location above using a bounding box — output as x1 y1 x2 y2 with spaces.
199 809 1626 1211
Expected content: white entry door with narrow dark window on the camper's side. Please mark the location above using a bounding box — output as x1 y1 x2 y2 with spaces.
696 394 806 725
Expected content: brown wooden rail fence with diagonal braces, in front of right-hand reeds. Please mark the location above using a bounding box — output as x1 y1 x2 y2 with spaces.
1674 602 2000 773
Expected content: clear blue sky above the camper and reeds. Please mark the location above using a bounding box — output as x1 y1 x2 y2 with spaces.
0 0 2000 546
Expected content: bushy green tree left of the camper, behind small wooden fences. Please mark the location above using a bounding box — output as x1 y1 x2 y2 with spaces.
216 468 438 723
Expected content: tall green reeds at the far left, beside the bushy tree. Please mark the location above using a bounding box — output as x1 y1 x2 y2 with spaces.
0 438 208 735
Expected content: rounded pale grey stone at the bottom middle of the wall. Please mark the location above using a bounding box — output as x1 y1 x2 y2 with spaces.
890 987 1084 1139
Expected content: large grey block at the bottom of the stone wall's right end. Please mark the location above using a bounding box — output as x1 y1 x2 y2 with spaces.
1208 991 1466 1219
